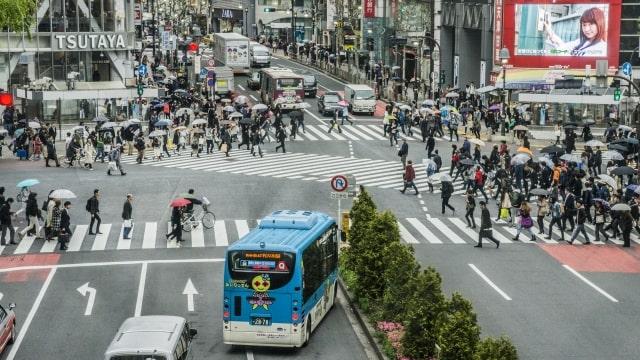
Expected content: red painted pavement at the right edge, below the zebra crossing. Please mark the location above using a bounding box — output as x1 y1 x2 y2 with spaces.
540 245 640 274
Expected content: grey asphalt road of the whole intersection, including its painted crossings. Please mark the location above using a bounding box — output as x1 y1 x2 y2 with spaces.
0 59 640 359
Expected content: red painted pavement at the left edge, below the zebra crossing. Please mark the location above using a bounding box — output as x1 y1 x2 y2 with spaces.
0 254 60 282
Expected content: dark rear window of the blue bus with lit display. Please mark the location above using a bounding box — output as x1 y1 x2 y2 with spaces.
225 250 295 290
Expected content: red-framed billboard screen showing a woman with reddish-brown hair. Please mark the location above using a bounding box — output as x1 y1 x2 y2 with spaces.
503 0 621 68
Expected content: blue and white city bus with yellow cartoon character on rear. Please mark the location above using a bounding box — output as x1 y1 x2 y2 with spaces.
222 210 338 347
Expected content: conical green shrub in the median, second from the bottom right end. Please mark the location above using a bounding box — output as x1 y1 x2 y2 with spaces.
438 293 480 360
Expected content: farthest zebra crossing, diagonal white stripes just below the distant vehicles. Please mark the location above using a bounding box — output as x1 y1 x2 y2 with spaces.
269 124 449 141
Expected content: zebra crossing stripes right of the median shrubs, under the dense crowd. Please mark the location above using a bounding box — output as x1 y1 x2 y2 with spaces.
398 217 640 246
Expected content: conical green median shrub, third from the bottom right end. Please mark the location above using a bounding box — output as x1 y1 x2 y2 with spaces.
402 267 446 359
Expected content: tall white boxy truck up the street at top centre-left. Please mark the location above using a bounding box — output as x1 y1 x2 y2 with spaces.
213 33 251 74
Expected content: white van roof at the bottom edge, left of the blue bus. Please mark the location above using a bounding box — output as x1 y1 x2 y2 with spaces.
104 315 198 360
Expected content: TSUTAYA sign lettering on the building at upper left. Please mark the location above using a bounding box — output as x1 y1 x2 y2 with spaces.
51 33 127 51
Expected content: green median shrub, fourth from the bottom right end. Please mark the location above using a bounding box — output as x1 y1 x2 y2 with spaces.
381 242 420 322
